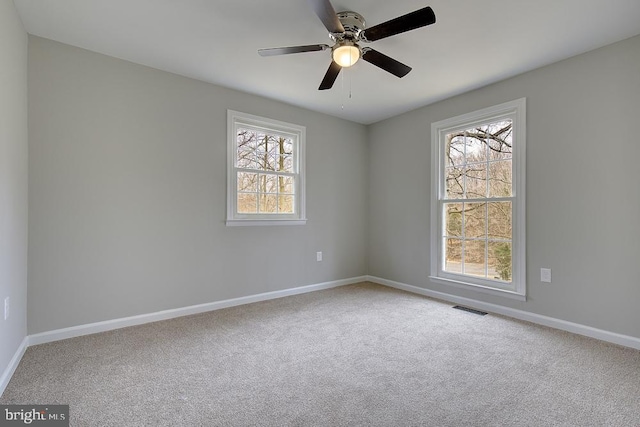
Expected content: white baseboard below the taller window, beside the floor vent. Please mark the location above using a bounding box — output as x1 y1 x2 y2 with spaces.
367 276 640 350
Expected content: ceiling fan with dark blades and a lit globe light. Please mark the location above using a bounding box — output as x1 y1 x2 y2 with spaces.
258 0 436 90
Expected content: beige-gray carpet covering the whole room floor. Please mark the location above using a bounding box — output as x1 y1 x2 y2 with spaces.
0 283 640 427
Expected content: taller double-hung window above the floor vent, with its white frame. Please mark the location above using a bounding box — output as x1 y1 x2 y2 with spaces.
431 98 526 300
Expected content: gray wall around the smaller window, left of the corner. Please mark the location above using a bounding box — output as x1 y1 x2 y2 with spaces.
29 36 368 334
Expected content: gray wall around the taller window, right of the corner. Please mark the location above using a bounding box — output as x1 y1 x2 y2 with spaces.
369 36 640 337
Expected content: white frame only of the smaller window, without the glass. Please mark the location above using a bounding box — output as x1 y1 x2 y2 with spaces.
226 110 307 226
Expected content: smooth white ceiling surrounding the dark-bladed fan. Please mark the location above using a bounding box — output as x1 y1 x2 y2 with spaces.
14 0 640 124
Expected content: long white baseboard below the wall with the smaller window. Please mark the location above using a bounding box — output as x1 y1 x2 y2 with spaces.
28 276 367 346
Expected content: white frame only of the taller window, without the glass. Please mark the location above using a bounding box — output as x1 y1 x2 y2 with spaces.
429 98 526 301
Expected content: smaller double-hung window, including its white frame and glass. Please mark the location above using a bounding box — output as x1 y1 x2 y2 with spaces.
227 110 306 225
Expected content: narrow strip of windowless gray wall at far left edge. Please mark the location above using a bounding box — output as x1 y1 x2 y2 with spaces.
0 0 28 375
